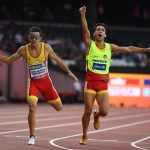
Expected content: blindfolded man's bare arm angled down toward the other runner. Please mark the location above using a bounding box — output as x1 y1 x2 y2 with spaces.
45 44 79 81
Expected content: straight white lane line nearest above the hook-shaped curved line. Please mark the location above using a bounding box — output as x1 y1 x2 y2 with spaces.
0 113 149 125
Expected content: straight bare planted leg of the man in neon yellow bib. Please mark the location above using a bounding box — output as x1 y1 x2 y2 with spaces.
82 92 95 137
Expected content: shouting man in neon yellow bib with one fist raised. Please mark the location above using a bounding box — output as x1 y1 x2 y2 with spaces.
79 6 150 145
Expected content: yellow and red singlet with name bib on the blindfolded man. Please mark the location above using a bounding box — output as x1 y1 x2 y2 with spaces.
25 43 49 79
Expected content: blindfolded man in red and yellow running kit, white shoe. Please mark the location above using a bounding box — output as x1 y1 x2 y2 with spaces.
0 27 78 145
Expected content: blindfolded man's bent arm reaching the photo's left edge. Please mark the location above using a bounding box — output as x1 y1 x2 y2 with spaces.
0 46 25 64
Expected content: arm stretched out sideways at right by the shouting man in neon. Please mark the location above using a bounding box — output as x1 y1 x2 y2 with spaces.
110 44 150 53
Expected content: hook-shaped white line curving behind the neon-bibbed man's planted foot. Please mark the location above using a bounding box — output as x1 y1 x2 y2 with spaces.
49 120 150 150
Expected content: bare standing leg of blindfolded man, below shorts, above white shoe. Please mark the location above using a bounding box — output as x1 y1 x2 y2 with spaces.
28 99 37 135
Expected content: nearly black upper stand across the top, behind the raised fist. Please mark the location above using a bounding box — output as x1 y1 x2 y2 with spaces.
0 0 150 27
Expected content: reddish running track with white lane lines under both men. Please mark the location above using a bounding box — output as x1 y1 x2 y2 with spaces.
0 103 150 150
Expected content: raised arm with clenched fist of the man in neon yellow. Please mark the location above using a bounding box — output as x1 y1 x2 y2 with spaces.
79 6 92 54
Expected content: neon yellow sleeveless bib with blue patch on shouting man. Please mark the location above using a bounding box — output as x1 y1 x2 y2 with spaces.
86 41 111 74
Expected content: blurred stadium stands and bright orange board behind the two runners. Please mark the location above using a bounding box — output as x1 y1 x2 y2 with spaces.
0 0 150 107
